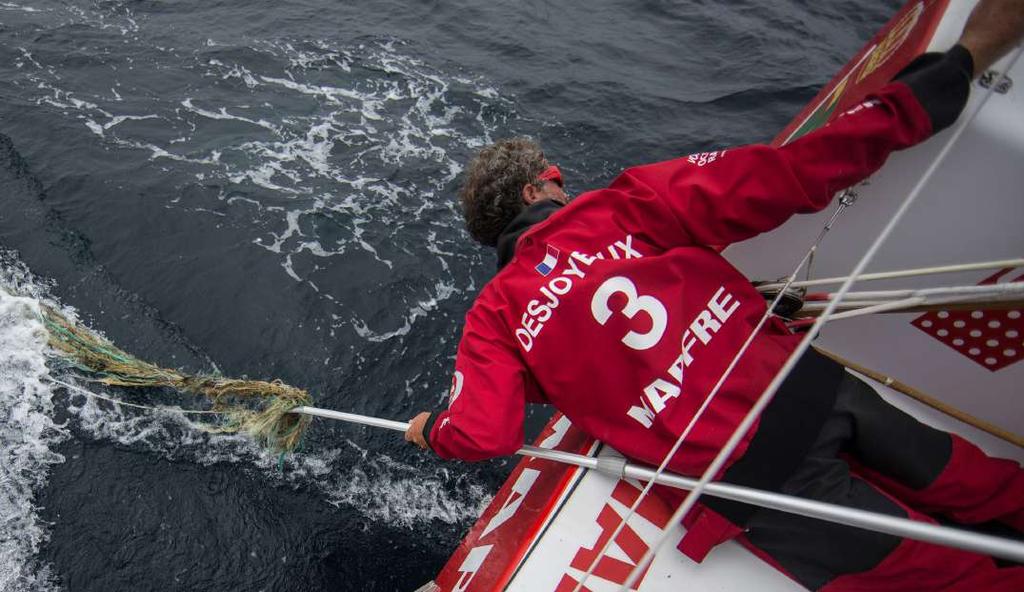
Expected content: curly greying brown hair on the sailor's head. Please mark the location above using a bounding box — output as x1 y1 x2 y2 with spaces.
459 137 548 247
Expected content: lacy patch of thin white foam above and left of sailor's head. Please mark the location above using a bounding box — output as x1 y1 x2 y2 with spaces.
18 31 514 341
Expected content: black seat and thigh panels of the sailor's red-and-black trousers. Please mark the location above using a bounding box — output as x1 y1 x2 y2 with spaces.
745 374 1021 590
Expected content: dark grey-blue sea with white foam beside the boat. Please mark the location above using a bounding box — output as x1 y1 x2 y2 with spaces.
0 0 900 592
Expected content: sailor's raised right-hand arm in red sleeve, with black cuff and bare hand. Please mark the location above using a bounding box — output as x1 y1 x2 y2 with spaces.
611 0 1024 247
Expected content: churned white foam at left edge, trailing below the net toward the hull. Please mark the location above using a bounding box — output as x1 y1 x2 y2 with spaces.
0 246 489 581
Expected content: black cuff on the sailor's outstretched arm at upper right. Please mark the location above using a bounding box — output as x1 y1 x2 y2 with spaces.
894 45 974 134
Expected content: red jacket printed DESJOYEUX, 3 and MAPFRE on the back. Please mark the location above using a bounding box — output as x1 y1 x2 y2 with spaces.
427 47 970 558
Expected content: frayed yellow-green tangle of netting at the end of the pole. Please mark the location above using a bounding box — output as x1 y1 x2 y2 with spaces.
41 305 312 453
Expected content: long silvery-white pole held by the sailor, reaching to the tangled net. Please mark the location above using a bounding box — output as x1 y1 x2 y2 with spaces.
292 407 1024 562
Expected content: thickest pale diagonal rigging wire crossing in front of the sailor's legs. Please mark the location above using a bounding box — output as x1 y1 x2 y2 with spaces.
618 47 1024 592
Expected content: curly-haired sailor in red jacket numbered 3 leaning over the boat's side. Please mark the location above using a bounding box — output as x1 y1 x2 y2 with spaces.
407 1 1024 590
